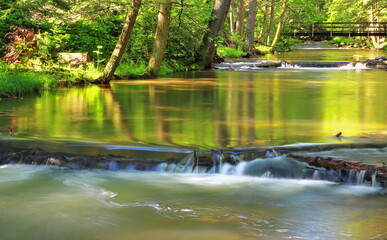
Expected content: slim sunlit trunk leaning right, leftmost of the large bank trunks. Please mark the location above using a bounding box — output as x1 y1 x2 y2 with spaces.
100 0 141 83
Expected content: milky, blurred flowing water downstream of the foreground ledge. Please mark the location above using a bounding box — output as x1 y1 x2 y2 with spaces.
0 165 387 240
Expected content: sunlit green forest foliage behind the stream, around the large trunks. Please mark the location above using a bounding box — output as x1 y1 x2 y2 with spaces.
0 0 387 96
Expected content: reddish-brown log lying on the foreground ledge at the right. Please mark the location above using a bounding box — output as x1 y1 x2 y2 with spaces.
287 154 387 186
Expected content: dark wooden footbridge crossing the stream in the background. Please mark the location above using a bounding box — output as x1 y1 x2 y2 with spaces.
289 22 387 39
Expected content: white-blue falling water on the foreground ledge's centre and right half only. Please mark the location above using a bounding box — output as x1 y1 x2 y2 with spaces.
152 153 380 187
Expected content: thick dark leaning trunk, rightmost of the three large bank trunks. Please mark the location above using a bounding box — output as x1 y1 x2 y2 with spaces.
198 0 231 69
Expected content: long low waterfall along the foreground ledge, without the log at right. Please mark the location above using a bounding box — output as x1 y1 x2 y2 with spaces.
6 144 386 187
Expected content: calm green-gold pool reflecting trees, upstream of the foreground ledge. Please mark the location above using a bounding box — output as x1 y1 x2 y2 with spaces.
0 65 387 147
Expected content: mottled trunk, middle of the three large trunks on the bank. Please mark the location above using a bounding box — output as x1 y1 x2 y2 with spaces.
148 0 172 77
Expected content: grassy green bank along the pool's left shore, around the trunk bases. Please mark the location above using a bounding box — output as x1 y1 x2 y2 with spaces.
0 58 198 98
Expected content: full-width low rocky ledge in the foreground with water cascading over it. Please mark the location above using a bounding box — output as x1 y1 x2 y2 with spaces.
0 143 387 187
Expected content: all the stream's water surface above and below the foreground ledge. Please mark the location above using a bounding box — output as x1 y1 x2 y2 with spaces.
0 47 387 240
